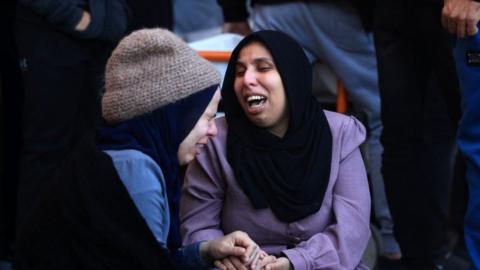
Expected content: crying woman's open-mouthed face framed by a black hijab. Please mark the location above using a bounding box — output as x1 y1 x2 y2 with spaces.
234 42 289 137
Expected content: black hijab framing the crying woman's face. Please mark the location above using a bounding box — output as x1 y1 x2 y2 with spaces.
222 31 332 222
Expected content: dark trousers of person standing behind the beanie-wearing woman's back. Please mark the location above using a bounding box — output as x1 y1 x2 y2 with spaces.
16 19 110 227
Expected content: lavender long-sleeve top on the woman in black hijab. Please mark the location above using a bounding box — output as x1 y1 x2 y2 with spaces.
180 111 370 270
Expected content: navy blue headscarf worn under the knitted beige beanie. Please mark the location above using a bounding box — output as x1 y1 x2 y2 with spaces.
97 85 218 248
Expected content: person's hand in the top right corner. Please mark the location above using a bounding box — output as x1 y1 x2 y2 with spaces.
442 0 480 38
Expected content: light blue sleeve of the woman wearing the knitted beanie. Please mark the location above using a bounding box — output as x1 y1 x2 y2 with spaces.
105 150 170 247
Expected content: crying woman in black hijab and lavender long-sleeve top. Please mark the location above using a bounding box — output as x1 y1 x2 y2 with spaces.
180 31 370 270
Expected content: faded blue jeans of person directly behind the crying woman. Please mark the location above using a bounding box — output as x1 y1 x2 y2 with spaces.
251 0 400 252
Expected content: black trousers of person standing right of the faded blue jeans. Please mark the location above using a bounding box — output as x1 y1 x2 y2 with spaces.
374 0 460 263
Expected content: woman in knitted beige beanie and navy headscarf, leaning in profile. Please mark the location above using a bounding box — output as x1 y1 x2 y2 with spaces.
15 29 257 270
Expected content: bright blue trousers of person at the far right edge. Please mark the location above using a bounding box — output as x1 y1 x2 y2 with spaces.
454 34 480 269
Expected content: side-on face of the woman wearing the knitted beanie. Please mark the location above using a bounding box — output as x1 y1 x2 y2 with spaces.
177 90 220 165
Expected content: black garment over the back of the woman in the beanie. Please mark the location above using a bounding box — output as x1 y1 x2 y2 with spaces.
14 136 176 270
